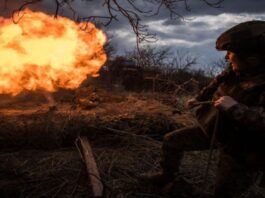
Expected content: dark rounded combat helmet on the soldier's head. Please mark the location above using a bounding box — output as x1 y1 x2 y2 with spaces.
216 21 265 52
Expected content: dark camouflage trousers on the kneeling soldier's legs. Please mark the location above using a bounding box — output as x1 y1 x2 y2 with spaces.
161 127 251 198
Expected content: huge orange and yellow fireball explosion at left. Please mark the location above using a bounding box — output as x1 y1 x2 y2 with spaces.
0 10 107 95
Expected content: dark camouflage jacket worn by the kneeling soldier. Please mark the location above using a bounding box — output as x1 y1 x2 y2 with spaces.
193 65 265 160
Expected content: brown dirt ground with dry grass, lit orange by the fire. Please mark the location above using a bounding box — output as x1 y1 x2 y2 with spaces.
0 86 264 198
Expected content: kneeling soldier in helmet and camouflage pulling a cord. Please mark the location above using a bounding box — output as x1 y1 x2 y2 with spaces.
141 21 265 198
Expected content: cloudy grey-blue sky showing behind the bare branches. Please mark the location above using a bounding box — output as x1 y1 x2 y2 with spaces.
0 0 265 65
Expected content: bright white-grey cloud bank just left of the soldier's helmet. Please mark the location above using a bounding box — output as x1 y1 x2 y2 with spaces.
149 13 265 62
